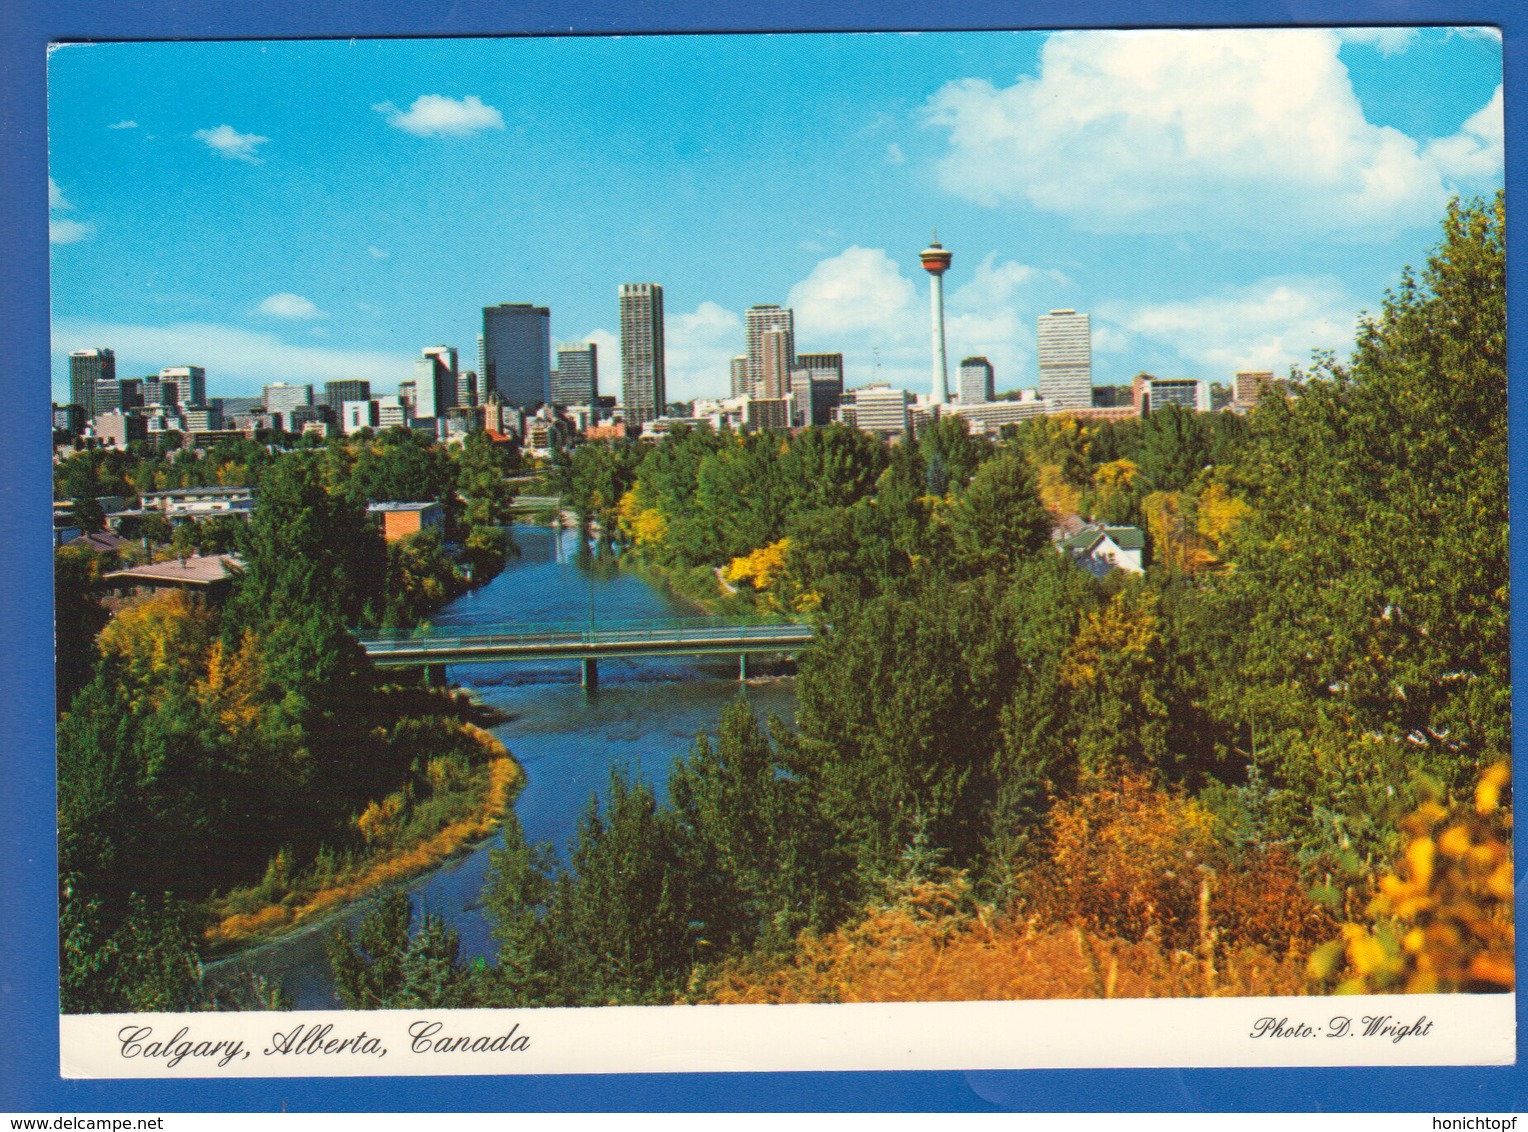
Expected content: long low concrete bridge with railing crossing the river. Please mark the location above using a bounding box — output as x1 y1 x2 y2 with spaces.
359 617 814 689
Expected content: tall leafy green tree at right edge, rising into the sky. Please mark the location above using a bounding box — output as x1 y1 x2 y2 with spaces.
1209 196 1510 837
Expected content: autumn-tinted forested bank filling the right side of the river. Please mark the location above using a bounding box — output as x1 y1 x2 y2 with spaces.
333 197 1513 1007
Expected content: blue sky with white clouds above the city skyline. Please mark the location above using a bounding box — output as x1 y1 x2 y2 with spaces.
49 29 1504 400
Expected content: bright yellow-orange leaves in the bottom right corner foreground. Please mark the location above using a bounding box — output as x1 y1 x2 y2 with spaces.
1308 762 1516 995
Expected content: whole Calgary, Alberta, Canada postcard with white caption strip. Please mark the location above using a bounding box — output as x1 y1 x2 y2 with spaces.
35 17 1517 1082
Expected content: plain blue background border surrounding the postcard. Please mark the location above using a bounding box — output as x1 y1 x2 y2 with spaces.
0 0 1528 1112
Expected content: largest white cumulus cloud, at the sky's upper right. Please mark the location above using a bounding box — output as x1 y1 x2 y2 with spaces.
923 29 1500 238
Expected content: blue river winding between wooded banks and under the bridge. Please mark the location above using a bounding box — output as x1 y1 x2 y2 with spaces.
217 526 796 1010
